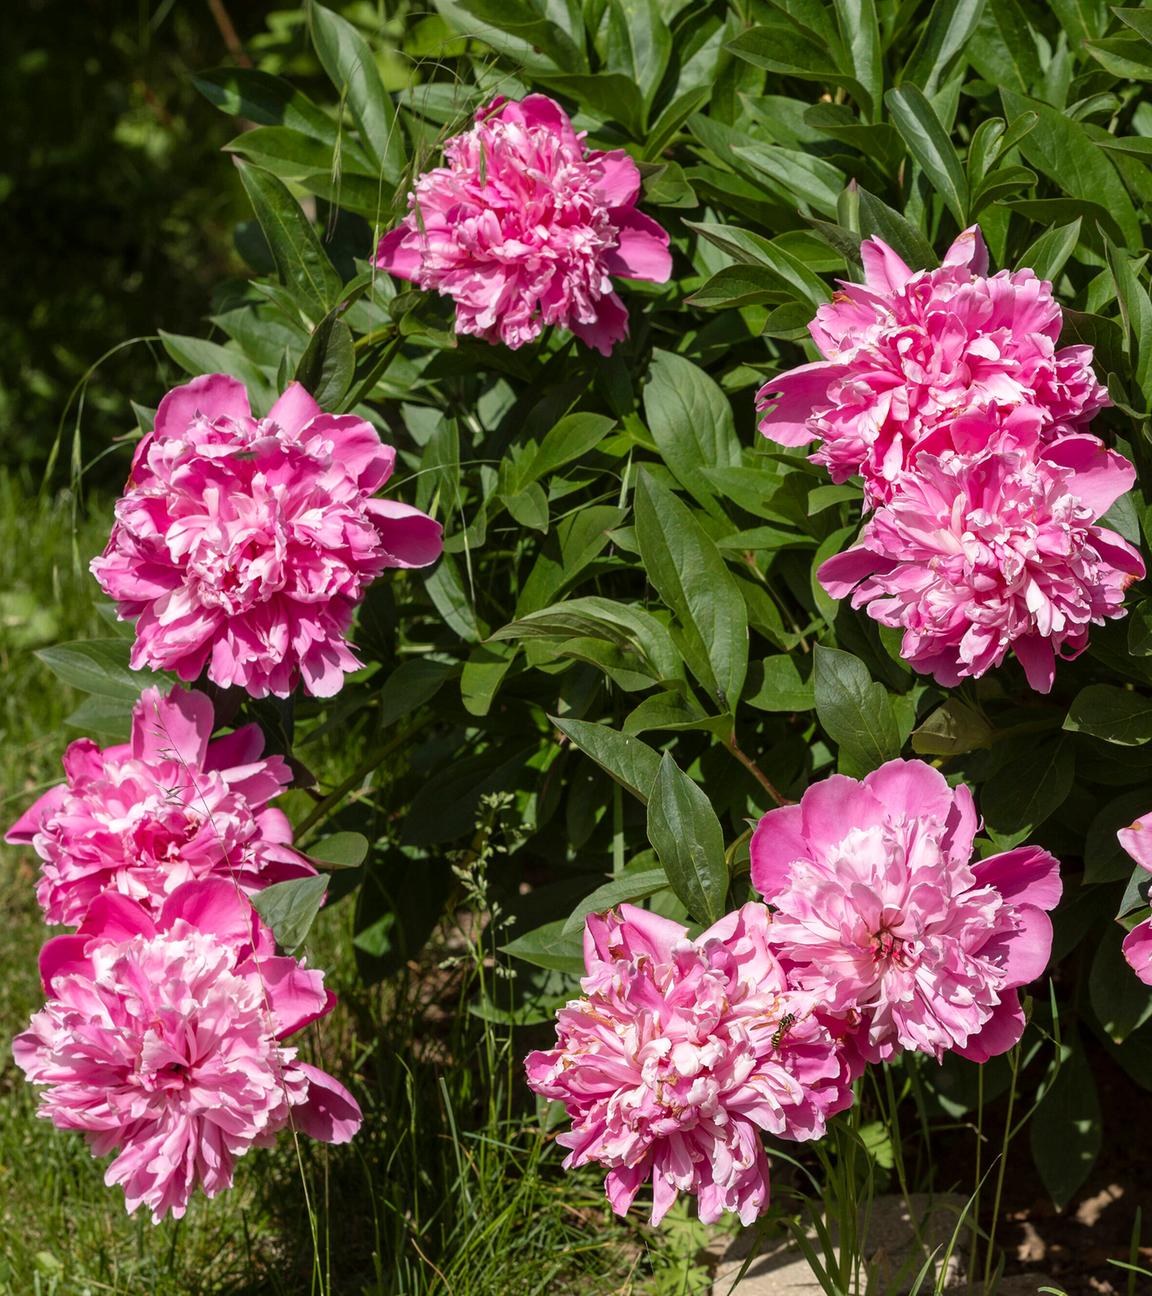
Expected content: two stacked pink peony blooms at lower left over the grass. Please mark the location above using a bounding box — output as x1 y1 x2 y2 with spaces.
8 686 360 1222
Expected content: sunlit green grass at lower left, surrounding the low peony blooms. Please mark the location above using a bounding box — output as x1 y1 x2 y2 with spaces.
0 474 708 1296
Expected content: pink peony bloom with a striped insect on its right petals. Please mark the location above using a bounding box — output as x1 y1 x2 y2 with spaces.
526 905 851 1223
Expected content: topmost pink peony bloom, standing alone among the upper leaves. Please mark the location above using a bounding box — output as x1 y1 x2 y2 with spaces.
376 95 671 355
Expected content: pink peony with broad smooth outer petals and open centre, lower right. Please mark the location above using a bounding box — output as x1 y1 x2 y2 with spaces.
752 761 1060 1061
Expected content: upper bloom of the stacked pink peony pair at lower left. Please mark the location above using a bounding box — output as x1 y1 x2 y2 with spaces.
6 686 316 927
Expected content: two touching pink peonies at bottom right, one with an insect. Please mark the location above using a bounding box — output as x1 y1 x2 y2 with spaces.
526 761 1060 1223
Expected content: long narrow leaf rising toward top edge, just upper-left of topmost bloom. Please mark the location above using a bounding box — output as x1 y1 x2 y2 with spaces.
308 3 408 183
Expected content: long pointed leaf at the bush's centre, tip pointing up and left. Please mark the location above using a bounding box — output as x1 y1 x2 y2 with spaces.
636 473 748 712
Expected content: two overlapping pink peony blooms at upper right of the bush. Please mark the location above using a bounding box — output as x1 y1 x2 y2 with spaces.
759 227 1144 692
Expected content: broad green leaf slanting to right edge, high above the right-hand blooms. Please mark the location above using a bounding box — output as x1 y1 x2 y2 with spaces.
1000 89 1142 248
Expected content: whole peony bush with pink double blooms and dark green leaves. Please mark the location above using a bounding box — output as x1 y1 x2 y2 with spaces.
9 0 1152 1275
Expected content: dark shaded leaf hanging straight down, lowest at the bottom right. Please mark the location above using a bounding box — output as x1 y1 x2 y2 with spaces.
1030 1041 1101 1210
